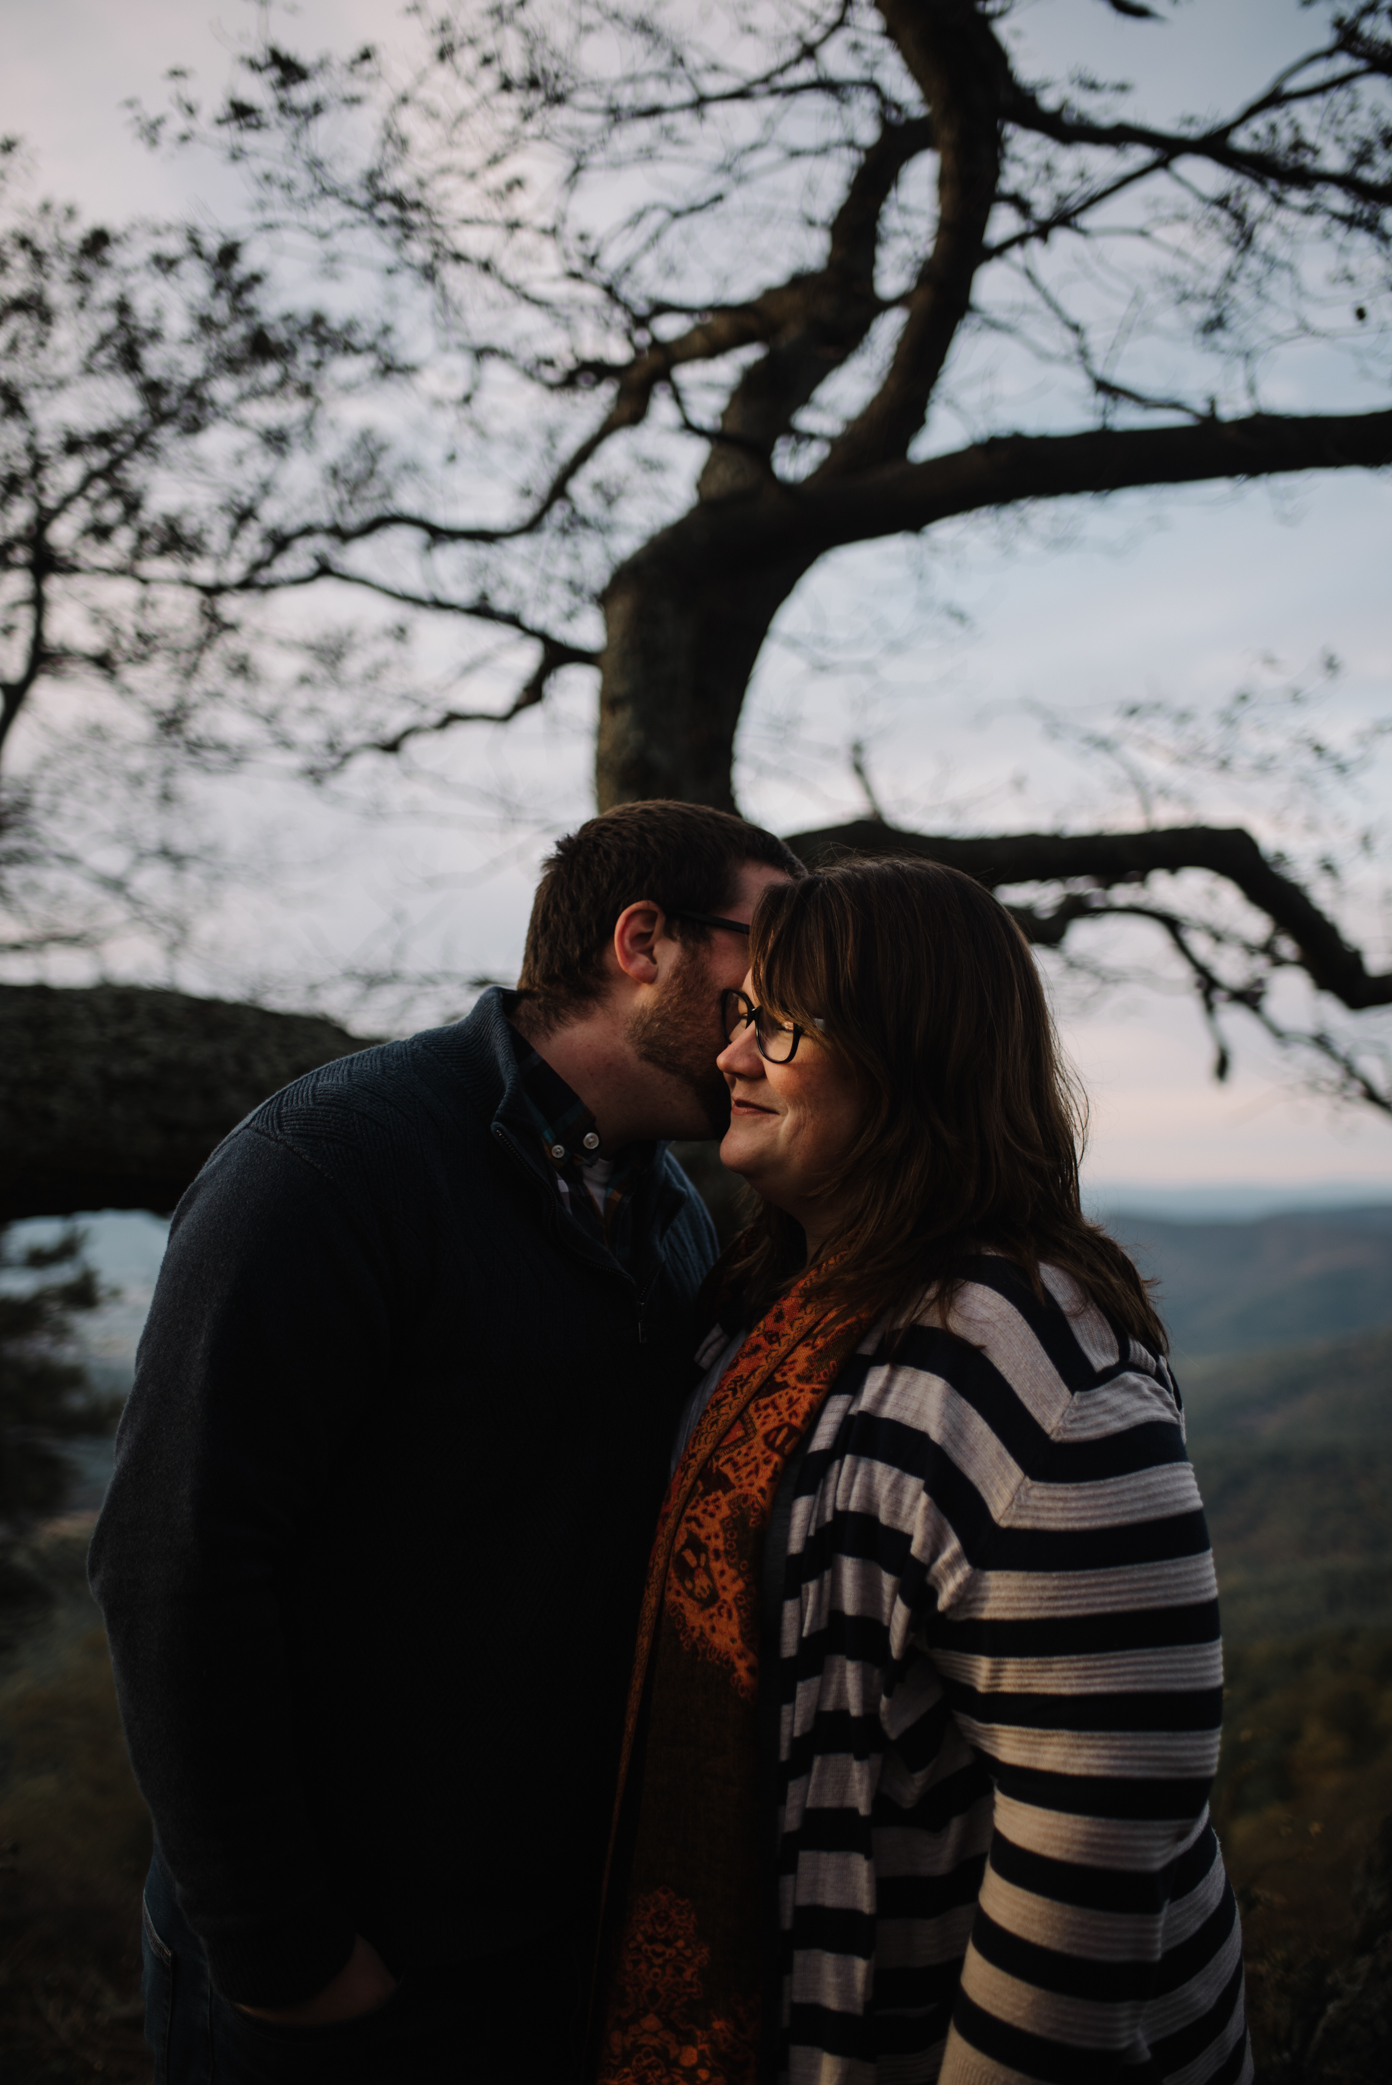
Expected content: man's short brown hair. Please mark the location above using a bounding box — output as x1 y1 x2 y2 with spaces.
517 801 806 1017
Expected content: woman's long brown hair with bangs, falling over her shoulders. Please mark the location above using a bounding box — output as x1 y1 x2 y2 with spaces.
731 859 1167 1353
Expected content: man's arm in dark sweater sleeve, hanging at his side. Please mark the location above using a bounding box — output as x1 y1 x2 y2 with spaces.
92 1128 390 2012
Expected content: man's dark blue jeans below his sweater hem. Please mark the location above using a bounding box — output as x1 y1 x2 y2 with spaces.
140 1856 583 2085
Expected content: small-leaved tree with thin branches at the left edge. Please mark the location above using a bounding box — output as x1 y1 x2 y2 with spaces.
0 150 402 957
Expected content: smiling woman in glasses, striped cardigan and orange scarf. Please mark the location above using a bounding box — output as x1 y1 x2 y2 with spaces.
598 861 1250 2085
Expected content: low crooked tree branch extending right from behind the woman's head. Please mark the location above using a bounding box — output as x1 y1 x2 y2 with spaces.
788 819 1392 1011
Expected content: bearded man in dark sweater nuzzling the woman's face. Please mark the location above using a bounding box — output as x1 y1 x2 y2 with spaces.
92 803 800 2085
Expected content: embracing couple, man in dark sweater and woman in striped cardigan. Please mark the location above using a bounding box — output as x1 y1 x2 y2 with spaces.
92 803 1250 2085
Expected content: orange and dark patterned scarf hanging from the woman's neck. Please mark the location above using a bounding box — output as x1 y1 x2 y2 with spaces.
598 1278 863 2085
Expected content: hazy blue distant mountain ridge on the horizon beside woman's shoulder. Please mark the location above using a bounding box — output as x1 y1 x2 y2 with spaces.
1107 1203 1392 1366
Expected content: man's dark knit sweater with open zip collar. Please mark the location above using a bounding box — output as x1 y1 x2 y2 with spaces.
92 992 715 2006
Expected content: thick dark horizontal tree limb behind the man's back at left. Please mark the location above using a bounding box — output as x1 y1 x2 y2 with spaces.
0 984 365 1222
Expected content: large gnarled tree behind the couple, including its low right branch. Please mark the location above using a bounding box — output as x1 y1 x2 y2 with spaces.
8 0 1392 1217
